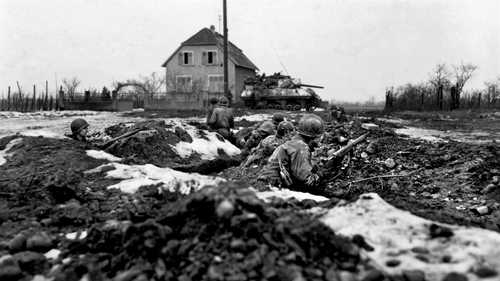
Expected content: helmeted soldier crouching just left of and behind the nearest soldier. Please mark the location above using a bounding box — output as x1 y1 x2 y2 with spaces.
243 121 295 167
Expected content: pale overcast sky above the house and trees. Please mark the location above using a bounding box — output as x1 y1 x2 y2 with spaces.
0 0 500 101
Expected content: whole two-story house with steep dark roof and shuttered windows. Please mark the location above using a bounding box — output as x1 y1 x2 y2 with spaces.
162 26 258 103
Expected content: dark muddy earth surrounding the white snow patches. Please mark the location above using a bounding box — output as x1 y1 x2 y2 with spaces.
0 108 500 280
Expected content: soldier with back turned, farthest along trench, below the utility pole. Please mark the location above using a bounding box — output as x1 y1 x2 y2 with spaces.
207 97 234 140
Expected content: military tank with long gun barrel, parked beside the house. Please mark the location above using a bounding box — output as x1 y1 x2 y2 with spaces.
241 73 324 111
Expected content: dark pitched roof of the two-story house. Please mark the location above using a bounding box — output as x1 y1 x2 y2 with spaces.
162 28 258 70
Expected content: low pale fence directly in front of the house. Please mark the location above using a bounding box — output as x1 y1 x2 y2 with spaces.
144 91 223 111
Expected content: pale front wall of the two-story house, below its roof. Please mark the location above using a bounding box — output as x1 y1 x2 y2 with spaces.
166 45 235 93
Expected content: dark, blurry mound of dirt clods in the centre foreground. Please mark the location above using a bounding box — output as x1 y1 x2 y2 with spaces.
53 184 361 280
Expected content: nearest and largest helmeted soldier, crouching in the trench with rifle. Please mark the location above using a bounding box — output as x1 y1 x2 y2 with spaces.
259 114 324 188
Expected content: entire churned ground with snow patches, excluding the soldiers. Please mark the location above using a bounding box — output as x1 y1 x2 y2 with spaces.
0 111 500 280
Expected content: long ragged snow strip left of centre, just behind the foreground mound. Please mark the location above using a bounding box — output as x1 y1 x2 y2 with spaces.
87 163 224 194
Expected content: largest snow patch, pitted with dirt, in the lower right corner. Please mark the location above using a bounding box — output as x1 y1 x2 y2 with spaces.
321 193 500 281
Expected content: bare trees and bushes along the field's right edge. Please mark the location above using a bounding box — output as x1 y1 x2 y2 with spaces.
385 64 500 111
